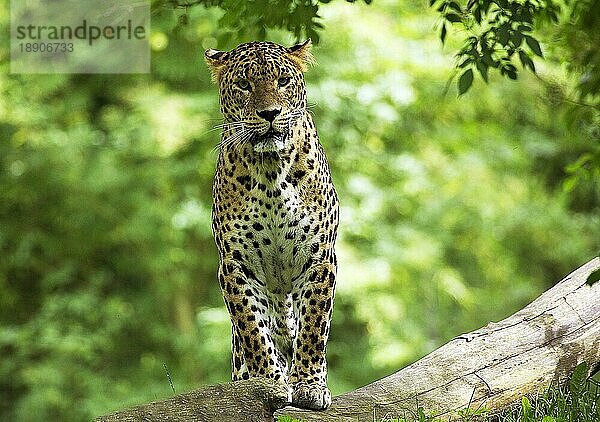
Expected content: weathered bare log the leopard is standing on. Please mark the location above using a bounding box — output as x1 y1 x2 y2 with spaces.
97 258 600 422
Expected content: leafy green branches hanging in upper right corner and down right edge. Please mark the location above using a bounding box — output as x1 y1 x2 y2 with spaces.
429 0 600 209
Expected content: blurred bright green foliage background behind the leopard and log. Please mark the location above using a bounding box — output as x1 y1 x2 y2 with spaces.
0 0 600 421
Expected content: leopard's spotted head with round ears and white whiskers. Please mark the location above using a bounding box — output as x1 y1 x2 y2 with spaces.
204 39 312 153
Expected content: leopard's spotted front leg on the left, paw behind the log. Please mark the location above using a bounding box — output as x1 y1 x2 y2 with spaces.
219 261 291 403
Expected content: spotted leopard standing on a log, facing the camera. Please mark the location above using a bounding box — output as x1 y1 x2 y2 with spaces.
204 39 339 410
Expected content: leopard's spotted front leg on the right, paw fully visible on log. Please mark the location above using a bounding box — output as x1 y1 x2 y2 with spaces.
289 258 336 410
